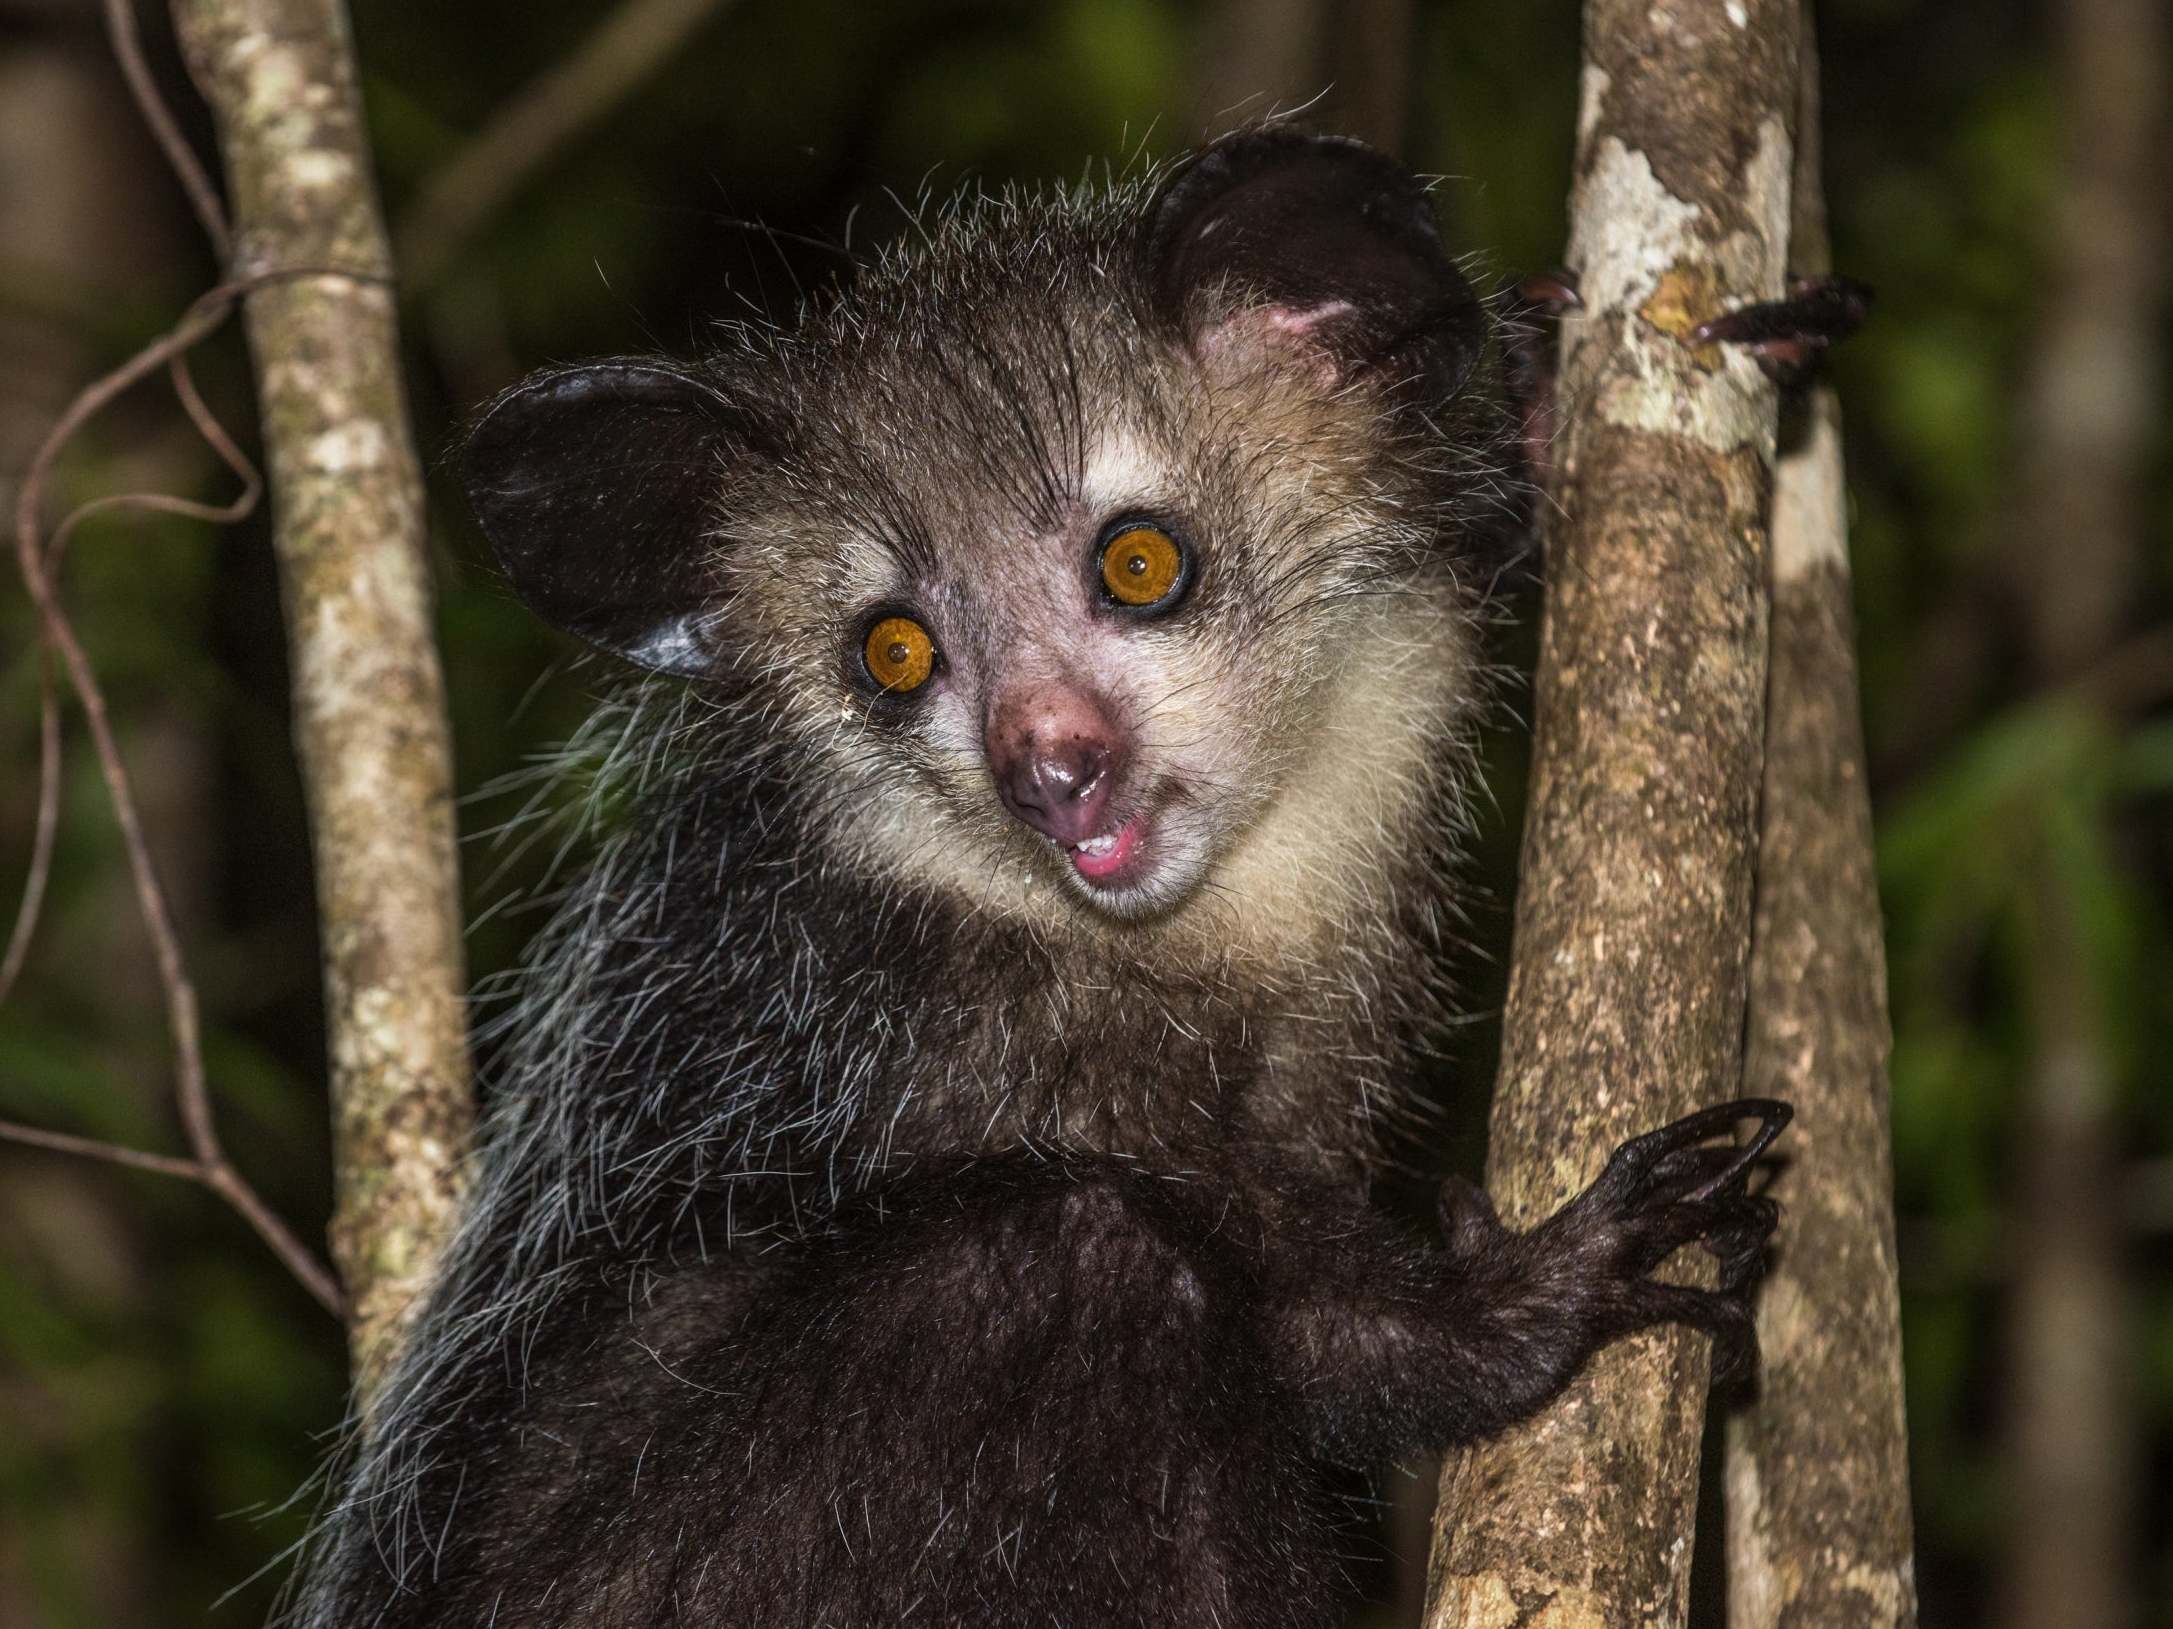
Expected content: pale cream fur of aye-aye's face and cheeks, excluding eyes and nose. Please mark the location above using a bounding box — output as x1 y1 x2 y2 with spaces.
748 348 1475 981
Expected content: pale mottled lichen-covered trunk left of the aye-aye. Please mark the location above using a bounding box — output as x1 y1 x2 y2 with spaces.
174 0 472 1397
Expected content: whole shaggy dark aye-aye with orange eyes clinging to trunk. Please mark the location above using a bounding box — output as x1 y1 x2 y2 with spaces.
296 128 1786 1629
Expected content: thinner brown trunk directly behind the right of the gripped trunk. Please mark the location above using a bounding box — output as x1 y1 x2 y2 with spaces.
1725 28 1917 1629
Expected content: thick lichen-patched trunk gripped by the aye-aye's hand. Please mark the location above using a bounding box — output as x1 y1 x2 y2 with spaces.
1428 0 1797 1629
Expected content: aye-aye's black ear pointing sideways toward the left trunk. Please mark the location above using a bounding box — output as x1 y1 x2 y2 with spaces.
463 361 756 675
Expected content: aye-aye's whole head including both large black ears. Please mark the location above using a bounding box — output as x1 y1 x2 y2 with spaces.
467 128 1517 951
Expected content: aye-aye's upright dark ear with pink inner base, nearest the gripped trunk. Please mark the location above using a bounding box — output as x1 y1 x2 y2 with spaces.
1143 126 1486 402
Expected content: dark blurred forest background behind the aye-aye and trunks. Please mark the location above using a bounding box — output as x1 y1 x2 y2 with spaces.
0 0 2173 1629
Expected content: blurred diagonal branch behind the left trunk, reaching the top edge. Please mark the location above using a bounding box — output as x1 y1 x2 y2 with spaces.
393 0 732 291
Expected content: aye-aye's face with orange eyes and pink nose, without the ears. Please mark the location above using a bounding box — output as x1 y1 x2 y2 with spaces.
724 337 1456 919
